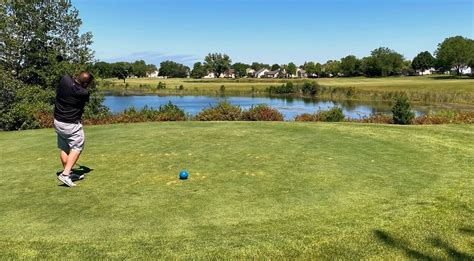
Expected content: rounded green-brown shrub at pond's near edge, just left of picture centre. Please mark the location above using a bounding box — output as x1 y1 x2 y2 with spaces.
196 101 242 121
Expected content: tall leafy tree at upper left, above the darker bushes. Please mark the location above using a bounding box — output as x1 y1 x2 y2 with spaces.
0 0 93 88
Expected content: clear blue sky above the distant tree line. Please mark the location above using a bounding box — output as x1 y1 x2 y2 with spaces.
73 0 474 65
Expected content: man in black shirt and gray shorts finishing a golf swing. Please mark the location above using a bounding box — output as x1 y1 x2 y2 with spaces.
54 72 94 187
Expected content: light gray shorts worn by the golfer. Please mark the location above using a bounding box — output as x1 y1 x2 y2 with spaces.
54 120 85 153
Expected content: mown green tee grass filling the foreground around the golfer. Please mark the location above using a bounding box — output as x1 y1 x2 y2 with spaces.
0 122 474 260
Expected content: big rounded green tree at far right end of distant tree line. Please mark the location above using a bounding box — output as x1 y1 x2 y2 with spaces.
435 36 474 75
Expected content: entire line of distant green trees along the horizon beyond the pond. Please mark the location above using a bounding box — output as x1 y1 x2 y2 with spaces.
90 36 474 80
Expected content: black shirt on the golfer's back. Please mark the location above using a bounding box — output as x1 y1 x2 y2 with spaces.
54 75 89 123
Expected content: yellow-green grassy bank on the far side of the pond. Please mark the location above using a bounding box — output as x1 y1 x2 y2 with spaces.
99 76 474 104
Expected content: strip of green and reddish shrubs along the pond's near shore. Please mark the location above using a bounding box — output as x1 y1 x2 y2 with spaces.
36 100 474 128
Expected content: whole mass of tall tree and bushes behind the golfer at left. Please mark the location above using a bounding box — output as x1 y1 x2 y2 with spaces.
0 0 105 130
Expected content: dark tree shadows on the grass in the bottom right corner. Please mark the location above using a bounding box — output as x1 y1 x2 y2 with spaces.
374 228 474 260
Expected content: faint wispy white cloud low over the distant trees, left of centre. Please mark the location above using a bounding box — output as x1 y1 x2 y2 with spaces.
99 51 200 66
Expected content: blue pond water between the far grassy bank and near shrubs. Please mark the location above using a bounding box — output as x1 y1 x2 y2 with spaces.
104 95 435 120
